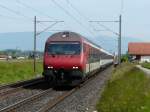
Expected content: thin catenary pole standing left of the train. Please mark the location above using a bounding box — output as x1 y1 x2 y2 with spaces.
33 16 36 73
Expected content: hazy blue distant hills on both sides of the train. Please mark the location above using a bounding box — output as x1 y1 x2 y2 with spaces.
0 32 141 53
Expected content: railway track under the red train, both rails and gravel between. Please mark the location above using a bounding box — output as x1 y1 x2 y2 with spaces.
0 65 110 112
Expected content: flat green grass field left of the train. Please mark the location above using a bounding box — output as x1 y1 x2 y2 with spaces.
0 60 43 84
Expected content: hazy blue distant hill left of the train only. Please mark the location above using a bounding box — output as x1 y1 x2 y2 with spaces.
0 32 51 51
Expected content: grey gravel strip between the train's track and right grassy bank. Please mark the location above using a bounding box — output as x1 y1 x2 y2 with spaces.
49 67 112 112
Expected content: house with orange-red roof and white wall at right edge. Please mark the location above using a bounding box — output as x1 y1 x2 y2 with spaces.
128 42 150 62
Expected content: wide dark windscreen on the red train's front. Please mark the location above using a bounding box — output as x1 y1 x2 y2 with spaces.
46 42 81 55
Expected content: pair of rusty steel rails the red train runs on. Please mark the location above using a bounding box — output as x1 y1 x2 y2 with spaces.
0 65 112 112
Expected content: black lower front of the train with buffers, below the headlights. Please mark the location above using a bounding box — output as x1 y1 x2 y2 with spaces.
43 69 84 86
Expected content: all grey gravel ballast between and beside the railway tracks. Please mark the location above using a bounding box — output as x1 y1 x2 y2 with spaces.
0 67 112 112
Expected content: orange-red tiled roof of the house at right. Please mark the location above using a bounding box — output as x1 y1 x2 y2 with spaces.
128 42 150 55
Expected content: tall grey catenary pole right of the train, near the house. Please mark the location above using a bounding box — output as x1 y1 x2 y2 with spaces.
118 15 122 65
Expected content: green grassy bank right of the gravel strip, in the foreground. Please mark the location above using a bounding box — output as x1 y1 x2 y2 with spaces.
96 63 150 112
